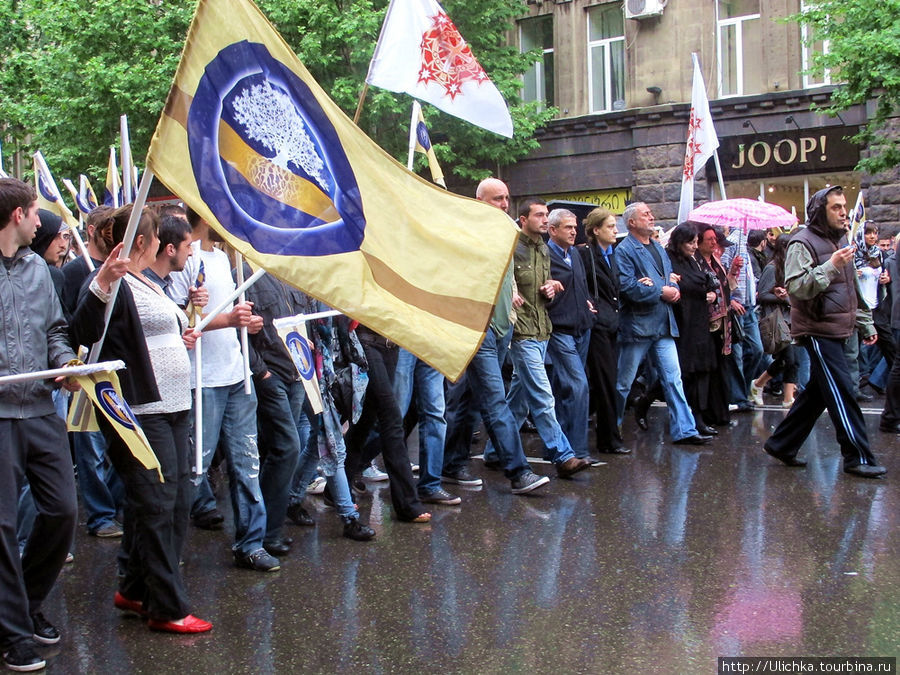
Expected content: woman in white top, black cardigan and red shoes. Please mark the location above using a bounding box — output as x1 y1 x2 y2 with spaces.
72 205 212 633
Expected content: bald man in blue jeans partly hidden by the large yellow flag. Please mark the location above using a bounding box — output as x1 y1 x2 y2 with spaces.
441 178 550 494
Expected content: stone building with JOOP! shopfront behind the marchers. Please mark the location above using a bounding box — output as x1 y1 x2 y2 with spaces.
502 0 900 230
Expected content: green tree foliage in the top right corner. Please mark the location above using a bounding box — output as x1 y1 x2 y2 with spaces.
790 0 900 173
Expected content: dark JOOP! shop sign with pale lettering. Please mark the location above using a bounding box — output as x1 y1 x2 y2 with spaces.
719 127 859 179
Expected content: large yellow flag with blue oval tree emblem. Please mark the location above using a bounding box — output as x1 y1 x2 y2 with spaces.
147 0 517 379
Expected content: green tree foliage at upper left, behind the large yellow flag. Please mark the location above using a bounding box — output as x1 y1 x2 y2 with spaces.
0 0 552 193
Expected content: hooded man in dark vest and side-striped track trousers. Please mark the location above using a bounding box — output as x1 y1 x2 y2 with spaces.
765 186 885 478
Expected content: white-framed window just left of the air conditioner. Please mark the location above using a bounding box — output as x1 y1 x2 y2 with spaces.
588 3 625 113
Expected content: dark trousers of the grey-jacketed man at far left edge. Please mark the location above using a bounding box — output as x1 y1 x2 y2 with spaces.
0 413 78 651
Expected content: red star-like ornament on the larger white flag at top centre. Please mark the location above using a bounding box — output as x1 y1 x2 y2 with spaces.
419 12 488 101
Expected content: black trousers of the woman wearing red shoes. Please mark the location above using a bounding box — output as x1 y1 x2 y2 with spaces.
97 410 193 621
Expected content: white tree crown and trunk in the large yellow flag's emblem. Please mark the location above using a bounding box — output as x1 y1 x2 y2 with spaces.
232 82 328 192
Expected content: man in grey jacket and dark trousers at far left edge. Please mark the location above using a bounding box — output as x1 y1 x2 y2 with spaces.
0 178 78 671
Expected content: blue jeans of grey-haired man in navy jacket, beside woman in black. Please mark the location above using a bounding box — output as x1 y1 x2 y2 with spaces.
547 331 591 457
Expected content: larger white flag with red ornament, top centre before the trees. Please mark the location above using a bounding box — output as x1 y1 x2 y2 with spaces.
366 0 512 138
